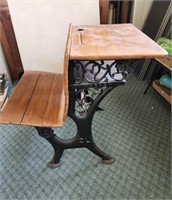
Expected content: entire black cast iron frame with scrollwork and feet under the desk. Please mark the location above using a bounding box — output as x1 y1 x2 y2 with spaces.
35 60 134 168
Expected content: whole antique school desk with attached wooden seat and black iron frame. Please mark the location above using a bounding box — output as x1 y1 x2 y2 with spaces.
0 24 167 168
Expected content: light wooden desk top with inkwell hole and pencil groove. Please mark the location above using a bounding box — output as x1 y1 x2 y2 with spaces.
70 24 167 60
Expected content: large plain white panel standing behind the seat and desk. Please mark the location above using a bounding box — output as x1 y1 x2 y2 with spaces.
8 0 99 73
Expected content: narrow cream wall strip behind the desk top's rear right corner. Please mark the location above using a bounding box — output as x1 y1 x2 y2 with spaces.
133 0 154 30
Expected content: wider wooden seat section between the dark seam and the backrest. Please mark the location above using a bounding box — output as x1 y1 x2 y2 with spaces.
21 72 65 127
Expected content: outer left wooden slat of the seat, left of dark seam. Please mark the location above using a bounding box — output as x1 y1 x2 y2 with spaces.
0 72 40 124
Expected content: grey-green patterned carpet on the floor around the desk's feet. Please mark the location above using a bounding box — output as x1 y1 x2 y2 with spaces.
0 76 171 200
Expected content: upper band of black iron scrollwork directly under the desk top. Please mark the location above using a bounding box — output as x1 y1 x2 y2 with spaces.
74 60 134 84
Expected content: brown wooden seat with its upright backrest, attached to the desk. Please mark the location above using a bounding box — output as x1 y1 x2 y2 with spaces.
0 25 71 127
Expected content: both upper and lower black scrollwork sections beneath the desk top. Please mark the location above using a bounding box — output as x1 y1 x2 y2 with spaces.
73 60 136 116
